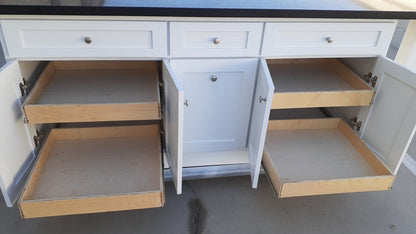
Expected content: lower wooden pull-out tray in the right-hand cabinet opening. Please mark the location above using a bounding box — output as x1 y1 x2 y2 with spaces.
263 118 394 197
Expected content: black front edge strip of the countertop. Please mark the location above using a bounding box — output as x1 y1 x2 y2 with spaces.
0 5 416 19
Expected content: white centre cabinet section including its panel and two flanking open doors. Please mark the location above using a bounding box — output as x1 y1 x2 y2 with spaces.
163 58 274 193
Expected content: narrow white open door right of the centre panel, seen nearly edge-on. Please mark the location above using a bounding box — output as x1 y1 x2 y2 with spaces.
248 58 274 188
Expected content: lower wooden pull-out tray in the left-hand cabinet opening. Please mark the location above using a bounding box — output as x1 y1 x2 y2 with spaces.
19 125 164 218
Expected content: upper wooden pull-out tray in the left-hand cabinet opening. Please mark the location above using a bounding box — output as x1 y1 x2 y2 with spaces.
23 61 160 124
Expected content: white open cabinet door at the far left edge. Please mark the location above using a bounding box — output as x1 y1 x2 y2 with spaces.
0 60 35 207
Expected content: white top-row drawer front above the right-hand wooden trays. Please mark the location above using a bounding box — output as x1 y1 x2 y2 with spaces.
262 22 396 57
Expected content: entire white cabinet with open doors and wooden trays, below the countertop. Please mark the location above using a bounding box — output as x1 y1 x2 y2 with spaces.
0 18 416 218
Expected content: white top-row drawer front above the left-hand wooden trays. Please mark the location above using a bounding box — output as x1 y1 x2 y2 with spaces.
1 20 167 58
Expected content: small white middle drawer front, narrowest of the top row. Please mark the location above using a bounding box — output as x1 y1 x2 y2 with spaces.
170 22 263 57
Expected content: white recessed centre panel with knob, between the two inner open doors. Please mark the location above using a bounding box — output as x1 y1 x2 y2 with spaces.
171 59 257 153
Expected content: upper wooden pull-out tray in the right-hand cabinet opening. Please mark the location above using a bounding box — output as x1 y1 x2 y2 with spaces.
268 59 374 109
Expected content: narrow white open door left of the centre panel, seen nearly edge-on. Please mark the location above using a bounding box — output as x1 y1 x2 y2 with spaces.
163 59 184 194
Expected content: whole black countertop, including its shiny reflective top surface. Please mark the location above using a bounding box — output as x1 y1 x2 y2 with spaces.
0 0 416 19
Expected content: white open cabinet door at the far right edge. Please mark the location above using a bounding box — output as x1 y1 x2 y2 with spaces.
361 57 416 174
